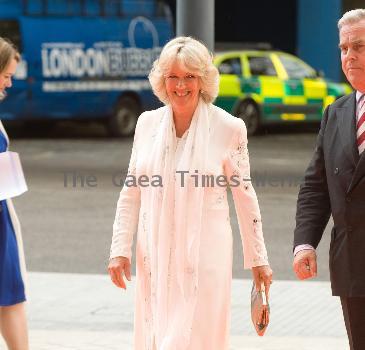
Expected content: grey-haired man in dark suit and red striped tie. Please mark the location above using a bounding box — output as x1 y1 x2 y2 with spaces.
293 9 365 350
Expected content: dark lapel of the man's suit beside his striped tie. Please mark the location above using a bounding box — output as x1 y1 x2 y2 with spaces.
336 93 359 166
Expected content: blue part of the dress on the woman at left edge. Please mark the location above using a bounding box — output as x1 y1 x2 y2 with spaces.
0 131 25 306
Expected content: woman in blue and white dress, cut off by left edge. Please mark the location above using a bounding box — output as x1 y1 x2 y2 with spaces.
0 37 28 350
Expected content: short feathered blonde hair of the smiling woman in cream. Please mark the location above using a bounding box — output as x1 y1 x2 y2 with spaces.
148 36 219 104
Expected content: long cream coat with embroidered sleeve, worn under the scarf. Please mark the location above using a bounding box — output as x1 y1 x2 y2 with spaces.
110 105 268 350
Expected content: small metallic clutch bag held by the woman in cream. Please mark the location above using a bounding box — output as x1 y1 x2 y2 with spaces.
251 282 270 337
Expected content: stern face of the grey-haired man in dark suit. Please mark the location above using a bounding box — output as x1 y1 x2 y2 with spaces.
339 19 365 93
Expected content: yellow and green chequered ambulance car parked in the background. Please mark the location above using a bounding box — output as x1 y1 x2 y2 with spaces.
214 50 352 135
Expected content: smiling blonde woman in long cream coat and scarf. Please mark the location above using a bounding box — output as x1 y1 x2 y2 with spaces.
109 37 272 350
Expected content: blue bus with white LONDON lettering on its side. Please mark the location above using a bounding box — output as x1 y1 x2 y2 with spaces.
0 0 173 136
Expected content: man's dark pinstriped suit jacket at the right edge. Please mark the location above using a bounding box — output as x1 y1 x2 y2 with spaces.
294 93 365 297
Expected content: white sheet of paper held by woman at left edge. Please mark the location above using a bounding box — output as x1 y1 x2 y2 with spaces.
0 152 28 200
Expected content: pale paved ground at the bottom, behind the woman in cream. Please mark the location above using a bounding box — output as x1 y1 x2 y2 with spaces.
0 272 348 350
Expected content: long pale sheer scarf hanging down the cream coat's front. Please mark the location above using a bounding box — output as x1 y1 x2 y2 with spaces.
146 100 210 350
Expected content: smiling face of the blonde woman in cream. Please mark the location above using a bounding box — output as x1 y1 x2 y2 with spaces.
165 61 201 113
